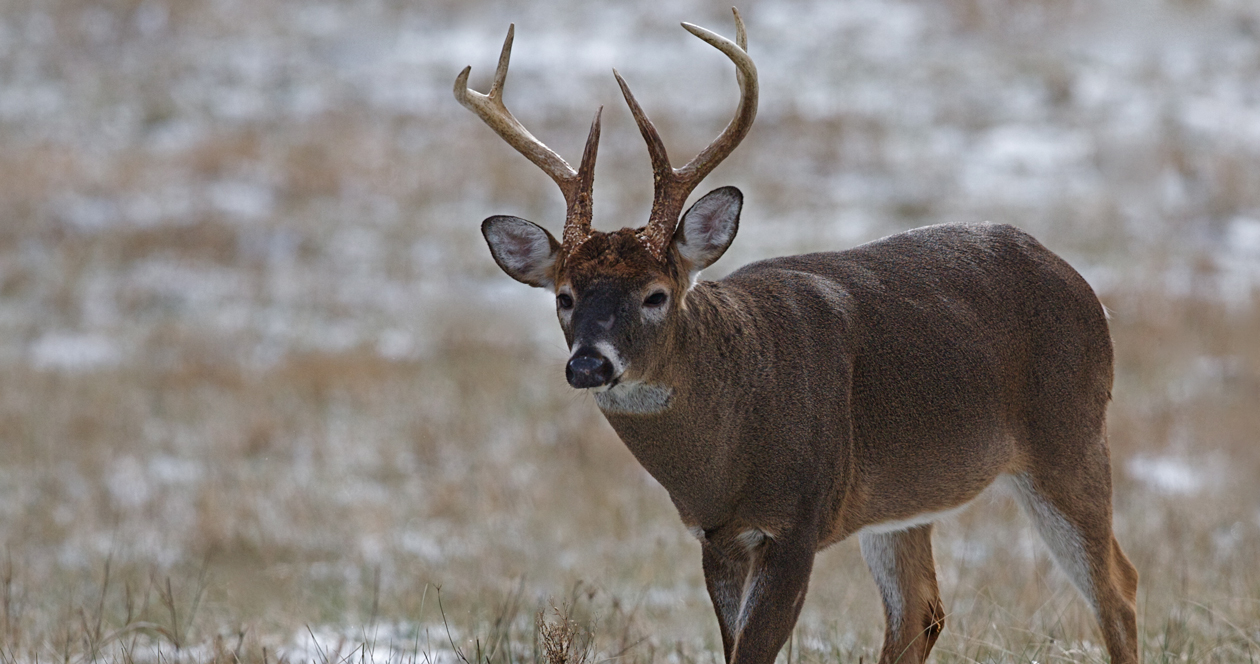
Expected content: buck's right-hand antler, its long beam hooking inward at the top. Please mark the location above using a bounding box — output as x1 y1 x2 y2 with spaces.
612 8 757 260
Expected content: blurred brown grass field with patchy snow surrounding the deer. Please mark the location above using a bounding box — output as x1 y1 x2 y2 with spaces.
0 0 1260 664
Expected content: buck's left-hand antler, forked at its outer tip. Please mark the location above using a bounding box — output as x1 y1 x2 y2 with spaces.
455 24 602 253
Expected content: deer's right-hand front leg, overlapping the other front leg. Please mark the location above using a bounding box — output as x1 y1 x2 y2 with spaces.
711 533 818 664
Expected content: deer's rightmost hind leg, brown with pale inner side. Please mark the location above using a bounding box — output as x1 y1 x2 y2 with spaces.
1012 473 1138 664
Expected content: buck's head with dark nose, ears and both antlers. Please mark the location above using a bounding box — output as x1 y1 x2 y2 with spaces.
455 10 757 391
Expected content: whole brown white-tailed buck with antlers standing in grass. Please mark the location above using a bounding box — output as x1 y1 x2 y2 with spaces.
455 11 1138 664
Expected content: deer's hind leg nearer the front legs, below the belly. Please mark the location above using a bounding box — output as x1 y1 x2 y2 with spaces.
858 524 945 664
